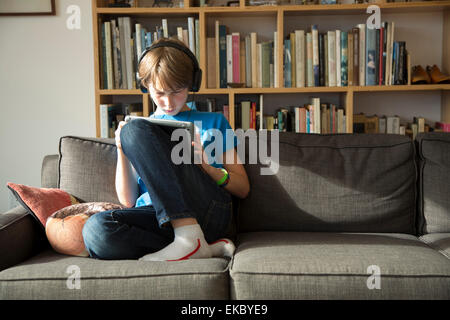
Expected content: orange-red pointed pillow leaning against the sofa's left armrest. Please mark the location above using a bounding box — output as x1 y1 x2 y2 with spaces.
7 182 81 227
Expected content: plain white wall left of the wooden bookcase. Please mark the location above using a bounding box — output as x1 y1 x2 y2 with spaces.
0 0 95 212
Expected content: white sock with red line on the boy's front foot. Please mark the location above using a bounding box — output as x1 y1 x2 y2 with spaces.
139 224 212 261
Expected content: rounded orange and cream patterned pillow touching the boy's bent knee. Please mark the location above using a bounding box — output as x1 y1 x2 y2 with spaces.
45 202 125 257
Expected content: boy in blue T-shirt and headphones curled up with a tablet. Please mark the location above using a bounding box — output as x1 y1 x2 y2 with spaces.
83 39 250 261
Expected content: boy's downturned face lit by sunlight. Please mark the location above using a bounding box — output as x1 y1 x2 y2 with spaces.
149 85 189 116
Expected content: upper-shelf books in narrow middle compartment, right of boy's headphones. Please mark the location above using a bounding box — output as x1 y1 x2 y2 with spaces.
206 20 278 88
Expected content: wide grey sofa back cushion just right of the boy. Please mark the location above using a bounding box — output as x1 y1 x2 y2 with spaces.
237 132 416 234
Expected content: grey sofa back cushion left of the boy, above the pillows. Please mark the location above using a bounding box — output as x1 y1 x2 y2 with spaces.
58 136 119 203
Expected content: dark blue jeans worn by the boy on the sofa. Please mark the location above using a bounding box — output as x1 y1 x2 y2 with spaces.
83 120 232 259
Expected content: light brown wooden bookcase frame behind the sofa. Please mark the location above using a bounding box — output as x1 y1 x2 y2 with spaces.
92 0 450 136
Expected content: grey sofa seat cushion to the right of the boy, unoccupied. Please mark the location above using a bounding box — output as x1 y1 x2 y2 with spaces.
230 232 450 299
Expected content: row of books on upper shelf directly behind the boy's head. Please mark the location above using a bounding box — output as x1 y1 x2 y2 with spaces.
100 17 200 90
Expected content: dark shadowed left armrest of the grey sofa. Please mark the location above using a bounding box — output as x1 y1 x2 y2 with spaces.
0 206 48 271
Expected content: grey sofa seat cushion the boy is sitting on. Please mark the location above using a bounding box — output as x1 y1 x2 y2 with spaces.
0 250 229 300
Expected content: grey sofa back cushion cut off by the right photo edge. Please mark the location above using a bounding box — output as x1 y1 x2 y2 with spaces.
416 132 450 234
